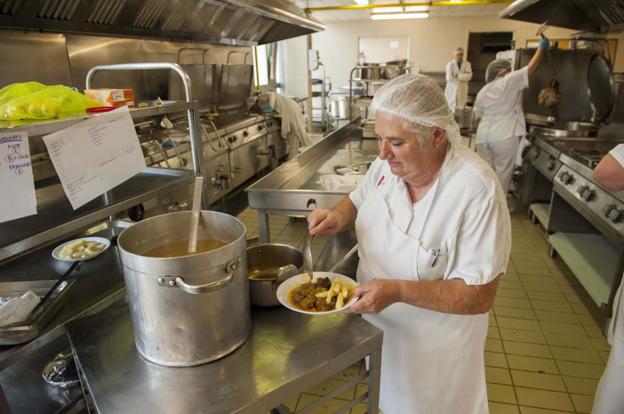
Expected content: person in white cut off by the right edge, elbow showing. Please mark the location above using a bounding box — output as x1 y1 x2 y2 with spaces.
592 144 624 414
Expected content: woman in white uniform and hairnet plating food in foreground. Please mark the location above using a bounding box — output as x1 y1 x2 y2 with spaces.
308 74 511 414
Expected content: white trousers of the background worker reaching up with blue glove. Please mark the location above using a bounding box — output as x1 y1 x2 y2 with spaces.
476 137 520 194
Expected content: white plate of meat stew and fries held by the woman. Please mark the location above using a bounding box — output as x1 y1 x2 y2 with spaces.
276 272 358 315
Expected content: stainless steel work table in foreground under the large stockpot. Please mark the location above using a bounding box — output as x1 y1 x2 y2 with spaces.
67 301 383 414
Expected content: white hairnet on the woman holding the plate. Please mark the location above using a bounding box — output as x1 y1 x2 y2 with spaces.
371 73 461 142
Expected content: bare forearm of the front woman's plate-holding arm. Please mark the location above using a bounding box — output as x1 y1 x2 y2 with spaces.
396 278 498 315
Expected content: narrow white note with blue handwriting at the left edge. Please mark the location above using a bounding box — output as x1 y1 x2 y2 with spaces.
0 132 37 223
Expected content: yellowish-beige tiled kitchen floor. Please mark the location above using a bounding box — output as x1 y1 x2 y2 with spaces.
239 209 610 414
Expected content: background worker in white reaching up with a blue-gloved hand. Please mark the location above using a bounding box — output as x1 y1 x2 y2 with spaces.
474 38 548 194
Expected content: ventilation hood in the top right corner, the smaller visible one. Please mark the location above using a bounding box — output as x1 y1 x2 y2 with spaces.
500 0 624 33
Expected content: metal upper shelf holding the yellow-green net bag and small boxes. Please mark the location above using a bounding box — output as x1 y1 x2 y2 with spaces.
0 101 199 137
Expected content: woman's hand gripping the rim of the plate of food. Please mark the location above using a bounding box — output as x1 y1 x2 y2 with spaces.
346 279 401 314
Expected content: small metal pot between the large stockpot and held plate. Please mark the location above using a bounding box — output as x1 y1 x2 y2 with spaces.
247 243 303 306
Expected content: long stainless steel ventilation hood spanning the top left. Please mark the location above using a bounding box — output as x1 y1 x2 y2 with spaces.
0 0 325 45
